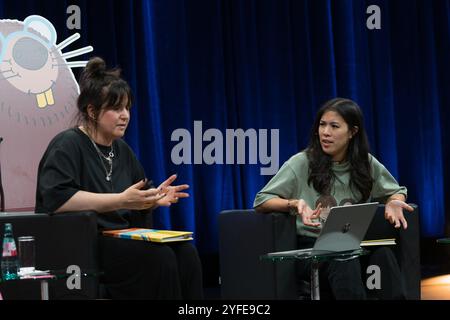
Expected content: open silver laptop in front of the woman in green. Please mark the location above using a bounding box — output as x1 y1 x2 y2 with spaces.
267 202 378 257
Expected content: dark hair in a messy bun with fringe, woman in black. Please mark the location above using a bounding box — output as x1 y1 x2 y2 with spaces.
76 57 133 128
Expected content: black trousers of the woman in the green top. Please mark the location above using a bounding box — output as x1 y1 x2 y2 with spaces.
297 237 406 300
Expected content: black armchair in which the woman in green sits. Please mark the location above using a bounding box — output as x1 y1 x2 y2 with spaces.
219 205 420 299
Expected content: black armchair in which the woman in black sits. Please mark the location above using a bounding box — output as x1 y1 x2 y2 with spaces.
0 212 98 300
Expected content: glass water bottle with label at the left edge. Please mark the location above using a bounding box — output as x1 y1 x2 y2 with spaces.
1 223 19 281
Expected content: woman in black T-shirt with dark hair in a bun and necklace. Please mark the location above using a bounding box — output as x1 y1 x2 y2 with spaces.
35 58 203 299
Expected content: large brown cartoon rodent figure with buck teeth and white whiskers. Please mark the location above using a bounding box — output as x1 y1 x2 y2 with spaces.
0 15 93 209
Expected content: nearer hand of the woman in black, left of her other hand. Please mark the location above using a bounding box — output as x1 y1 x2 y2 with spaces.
120 179 165 210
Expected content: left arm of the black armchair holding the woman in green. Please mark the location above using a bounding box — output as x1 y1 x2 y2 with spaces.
218 210 297 299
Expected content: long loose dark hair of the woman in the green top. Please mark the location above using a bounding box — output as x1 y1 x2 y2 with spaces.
306 98 373 202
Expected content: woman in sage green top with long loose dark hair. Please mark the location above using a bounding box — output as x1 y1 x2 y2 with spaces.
254 98 413 299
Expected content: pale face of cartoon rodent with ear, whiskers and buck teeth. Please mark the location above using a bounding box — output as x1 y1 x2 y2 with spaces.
0 15 93 108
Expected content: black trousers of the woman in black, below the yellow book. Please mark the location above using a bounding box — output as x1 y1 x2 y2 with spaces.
99 236 203 300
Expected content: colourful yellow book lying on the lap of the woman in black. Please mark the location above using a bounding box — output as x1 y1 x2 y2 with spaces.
103 228 193 243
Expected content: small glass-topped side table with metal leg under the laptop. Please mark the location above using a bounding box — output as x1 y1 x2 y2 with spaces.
260 248 369 300
